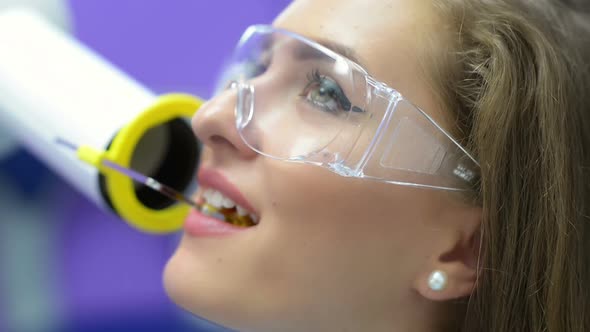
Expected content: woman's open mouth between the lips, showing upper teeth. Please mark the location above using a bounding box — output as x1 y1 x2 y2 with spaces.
198 188 259 227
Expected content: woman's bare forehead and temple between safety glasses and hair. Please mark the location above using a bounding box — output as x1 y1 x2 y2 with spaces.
274 0 450 127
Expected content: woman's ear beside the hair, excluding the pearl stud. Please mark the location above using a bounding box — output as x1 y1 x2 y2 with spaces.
414 207 482 301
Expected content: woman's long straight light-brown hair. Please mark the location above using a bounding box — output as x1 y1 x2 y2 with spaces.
431 0 590 332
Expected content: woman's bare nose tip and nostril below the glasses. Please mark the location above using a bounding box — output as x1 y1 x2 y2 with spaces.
191 87 257 159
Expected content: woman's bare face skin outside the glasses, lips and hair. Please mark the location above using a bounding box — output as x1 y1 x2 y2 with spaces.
164 0 481 331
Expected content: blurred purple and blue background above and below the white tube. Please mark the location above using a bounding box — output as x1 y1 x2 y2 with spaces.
0 0 289 332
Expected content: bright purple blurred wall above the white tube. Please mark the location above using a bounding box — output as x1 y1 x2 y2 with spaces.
70 0 289 97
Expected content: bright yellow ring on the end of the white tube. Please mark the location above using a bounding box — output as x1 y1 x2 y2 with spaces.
103 94 203 233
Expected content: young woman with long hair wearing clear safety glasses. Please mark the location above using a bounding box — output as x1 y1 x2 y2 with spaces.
165 0 590 332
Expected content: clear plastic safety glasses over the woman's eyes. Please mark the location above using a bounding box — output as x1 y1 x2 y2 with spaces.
216 25 479 190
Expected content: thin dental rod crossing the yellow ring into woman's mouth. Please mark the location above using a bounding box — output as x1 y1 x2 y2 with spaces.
55 138 258 227
